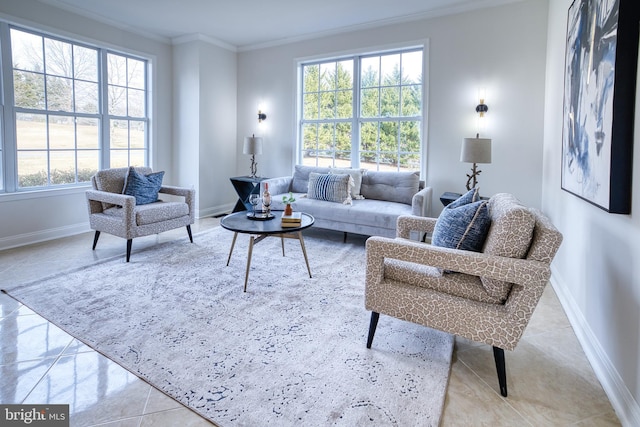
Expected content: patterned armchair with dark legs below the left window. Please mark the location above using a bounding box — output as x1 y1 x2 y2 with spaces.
86 167 195 262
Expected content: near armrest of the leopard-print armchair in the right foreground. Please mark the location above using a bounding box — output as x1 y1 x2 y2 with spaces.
366 236 551 288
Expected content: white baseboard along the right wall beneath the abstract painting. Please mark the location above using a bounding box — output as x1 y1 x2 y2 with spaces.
551 268 640 426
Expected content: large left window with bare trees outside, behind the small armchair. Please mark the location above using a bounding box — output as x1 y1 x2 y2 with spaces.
0 23 149 191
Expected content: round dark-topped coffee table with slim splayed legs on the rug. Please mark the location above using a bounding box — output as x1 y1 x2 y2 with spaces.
220 211 315 292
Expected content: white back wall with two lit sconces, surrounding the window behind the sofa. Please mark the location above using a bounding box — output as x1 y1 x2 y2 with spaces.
237 0 547 215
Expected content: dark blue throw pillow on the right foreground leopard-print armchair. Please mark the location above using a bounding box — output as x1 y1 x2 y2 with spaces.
431 189 491 252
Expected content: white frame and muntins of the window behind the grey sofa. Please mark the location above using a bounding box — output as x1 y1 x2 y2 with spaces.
293 44 429 176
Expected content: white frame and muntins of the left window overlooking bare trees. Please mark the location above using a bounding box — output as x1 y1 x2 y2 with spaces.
0 20 154 196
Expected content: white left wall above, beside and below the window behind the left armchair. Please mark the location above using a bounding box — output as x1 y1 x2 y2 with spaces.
0 0 175 249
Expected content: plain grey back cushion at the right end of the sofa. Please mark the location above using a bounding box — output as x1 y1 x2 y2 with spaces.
360 171 420 205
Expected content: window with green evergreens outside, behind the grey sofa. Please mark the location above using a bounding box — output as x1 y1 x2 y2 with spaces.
298 49 422 171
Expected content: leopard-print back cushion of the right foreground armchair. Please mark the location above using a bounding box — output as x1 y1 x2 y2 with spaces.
482 193 536 300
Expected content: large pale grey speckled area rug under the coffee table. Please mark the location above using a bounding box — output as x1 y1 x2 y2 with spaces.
6 228 453 426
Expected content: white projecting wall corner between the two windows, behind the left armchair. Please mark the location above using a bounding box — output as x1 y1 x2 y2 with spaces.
173 39 237 216
